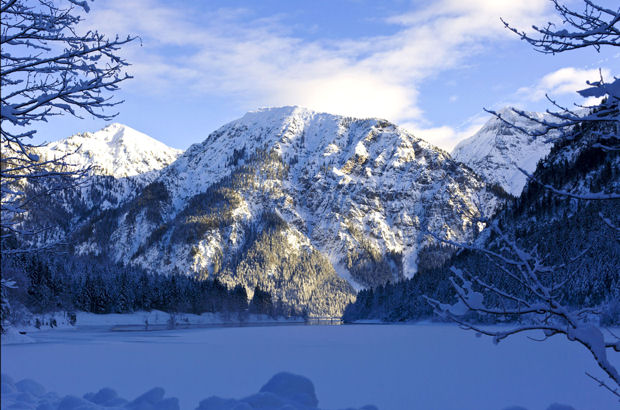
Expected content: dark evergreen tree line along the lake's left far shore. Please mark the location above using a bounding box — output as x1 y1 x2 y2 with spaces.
2 254 304 326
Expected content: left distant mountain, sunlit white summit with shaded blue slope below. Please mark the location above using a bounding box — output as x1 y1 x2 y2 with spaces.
15 123 182 246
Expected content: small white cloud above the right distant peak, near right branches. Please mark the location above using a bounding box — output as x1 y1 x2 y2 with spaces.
517 67 611 104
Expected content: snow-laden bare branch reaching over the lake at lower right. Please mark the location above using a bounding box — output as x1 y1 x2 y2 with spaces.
426 223 620 397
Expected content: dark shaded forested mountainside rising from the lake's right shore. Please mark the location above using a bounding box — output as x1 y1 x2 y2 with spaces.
344 111 620 326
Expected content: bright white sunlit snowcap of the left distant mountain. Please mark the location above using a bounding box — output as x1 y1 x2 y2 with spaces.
41 123 182 179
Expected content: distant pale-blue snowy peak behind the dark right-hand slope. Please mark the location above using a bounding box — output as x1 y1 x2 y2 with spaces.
452 108 553 196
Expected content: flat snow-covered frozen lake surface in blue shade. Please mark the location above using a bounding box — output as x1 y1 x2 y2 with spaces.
1 324 620 410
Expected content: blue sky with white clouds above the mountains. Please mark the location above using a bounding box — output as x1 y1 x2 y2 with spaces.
30 0 620 150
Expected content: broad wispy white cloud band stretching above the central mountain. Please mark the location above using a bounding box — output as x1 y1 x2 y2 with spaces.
80 0 548 130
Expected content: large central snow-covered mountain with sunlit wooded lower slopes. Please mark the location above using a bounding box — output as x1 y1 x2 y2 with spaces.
64 107 498 315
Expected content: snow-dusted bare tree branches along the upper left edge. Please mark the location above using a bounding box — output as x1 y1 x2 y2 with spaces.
0 0 136 252
